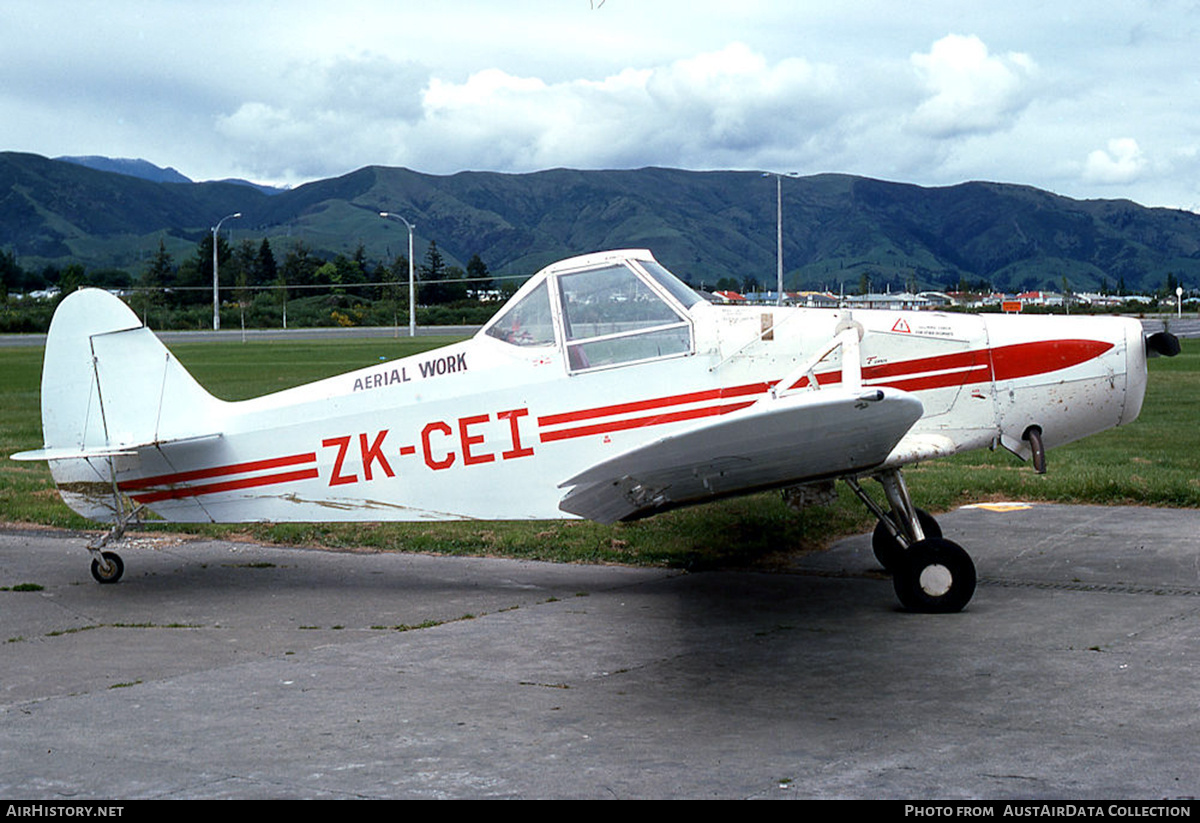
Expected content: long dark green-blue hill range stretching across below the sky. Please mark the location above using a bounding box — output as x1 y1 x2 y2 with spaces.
7 152 1200 292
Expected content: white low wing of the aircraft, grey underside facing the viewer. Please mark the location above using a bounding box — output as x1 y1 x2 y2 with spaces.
558 389 923 523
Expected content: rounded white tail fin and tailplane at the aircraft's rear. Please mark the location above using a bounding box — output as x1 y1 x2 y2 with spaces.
12 289 224 519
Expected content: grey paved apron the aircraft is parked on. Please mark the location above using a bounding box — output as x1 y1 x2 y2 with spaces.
0 505 1200 800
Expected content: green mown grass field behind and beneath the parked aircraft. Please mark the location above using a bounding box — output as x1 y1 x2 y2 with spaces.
0 337 1200 567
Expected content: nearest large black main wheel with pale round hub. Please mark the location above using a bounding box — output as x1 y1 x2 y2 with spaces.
892 537 976 614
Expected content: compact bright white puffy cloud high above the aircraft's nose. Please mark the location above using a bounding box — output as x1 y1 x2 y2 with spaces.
911 35 1037 137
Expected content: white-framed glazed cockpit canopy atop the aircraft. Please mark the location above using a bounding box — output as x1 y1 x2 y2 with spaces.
484 251 702 372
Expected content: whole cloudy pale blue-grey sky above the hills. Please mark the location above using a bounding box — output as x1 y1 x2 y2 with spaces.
0 0 1200 211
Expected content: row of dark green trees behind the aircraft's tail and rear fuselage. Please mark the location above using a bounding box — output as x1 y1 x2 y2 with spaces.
0 234 516 331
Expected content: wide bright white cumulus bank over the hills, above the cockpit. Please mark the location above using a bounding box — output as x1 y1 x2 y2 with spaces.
414 43 836 170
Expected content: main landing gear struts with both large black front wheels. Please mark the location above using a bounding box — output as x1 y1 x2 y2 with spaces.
846 469 976 613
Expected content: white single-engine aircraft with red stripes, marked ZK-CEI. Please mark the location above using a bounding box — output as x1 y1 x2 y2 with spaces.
13 250 1178 612
